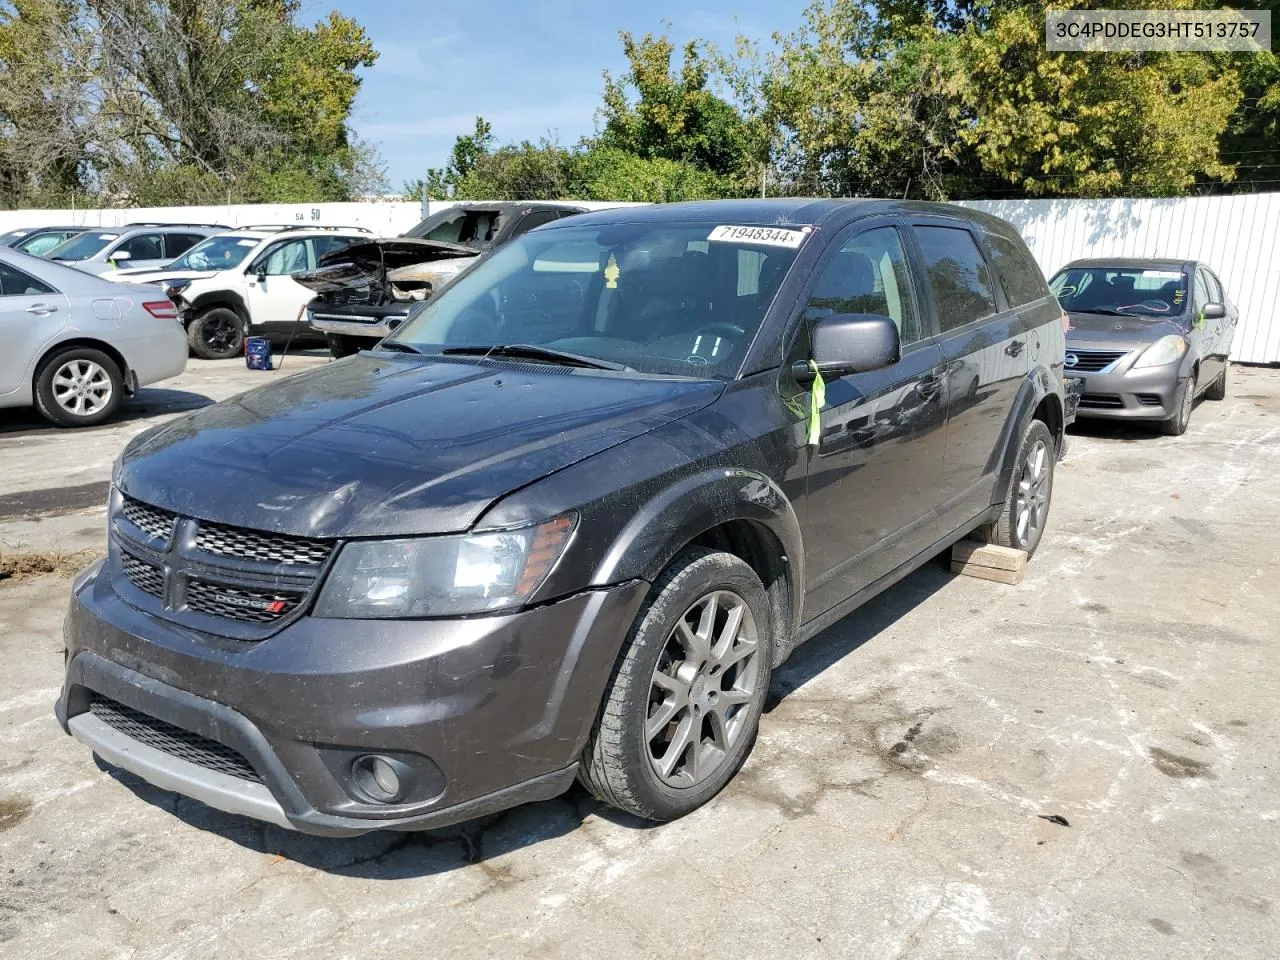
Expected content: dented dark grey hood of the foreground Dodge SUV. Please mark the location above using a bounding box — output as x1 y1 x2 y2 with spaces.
115 355 723 538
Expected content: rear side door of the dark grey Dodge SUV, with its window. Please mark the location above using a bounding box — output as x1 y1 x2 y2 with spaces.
911 218 1030 517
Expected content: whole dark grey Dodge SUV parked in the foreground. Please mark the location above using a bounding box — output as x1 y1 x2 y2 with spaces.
58 200 1070 835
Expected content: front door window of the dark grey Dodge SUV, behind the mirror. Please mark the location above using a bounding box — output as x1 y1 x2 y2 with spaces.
805 227 922 346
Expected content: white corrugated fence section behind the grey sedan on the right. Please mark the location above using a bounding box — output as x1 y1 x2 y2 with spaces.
965 193 1280 364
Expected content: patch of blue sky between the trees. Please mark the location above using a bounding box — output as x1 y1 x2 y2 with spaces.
302 0 805 189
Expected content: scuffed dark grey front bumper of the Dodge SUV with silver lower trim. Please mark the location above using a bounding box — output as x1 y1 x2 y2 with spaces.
56 571 648 836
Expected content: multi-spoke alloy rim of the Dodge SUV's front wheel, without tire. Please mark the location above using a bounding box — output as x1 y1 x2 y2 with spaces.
644 590 763 787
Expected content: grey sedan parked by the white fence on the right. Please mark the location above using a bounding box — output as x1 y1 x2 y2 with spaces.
1050 259 1238 436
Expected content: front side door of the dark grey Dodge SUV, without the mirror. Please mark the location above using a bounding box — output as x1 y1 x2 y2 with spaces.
800 220 946 620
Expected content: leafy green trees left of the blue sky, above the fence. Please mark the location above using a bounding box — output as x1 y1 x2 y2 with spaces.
0 0 381 204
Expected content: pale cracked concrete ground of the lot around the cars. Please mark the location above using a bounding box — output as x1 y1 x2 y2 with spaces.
0 364 1280 960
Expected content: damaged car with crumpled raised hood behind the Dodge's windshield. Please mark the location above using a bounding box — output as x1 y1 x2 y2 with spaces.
304 202 584 357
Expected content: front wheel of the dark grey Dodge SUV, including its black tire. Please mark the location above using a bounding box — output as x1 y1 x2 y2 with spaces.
579 548 772 820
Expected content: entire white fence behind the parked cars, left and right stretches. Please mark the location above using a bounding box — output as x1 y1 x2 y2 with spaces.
0 193 1280 364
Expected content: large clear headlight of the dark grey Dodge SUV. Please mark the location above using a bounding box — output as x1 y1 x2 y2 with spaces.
315 513 577 620
